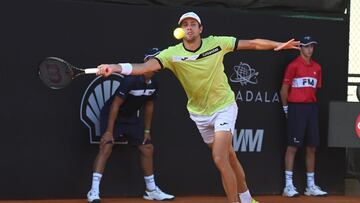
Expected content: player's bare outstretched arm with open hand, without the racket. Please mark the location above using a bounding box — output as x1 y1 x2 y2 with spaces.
237 39 300 51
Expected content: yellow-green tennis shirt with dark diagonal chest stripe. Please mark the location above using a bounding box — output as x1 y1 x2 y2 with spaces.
156 36 236 115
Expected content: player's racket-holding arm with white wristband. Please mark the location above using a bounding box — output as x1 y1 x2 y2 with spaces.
96 59 161 77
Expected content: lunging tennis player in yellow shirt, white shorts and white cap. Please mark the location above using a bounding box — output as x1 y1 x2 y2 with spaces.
97 12 299 203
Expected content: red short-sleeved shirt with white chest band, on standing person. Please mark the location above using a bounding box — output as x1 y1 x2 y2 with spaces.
283 56 322 103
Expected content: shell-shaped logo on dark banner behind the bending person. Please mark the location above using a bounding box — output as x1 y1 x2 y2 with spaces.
80 74 127 144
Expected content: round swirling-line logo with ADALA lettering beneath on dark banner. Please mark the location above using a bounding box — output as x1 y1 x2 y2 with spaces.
229 62 280 103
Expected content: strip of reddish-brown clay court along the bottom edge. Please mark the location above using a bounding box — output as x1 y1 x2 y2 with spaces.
0 195 360 203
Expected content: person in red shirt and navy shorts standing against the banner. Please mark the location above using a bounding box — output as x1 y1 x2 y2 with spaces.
280 36 327 197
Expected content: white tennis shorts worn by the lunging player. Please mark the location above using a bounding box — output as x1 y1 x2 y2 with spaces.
190 103 238 144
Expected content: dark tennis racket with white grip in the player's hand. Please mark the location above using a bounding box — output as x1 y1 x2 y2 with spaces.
38 57 99 89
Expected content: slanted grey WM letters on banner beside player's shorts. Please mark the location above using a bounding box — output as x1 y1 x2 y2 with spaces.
233 129 264 152
